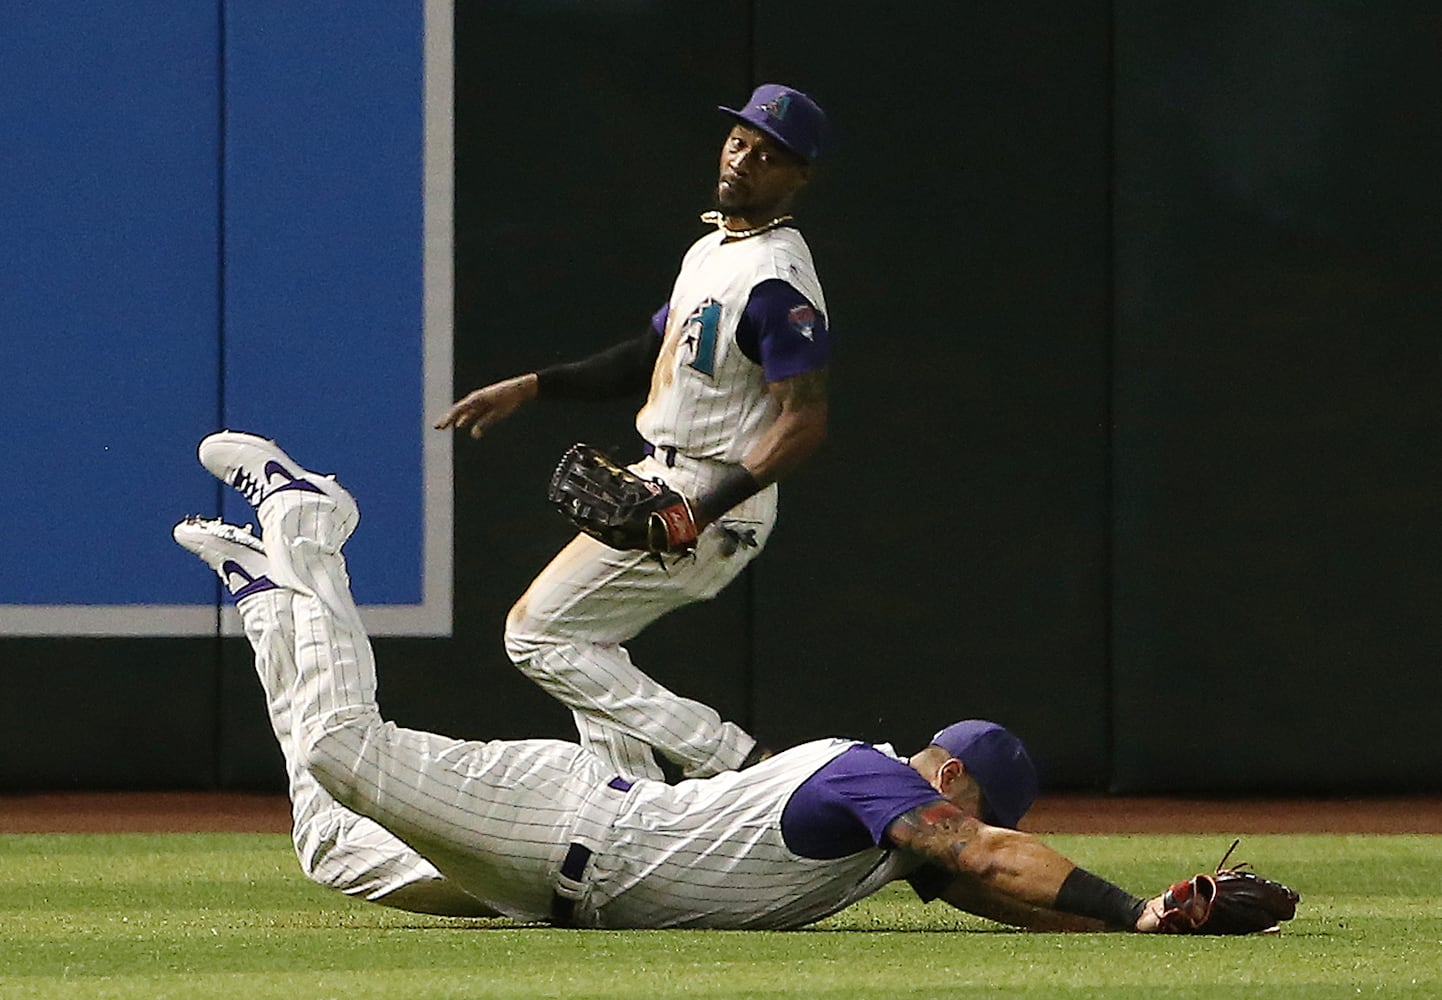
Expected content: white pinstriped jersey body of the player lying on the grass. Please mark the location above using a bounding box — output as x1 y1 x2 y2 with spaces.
580 739 917 928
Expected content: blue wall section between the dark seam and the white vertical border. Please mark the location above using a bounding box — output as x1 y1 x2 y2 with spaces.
224 0 434 605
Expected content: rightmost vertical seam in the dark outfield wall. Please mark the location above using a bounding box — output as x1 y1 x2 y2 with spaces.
1102 0 1118 791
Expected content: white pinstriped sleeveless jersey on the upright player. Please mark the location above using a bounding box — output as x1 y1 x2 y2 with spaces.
636 227 826 462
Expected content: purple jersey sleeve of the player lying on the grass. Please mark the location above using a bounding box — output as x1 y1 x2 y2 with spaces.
782 743 942 860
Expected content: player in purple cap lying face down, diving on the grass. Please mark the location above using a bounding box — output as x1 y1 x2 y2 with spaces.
174 431 1291 931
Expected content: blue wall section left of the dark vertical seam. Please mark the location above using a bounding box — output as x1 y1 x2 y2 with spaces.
0 0 219 608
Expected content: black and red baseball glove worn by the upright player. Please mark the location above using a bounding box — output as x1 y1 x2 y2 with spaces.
547 444 696 554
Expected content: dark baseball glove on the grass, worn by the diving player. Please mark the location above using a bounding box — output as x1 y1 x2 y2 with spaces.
1161 841 1301 934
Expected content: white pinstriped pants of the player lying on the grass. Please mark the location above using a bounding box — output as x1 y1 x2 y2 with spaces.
241 494 614 921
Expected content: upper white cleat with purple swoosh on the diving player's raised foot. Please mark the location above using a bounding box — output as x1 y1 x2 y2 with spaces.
198 430 361 548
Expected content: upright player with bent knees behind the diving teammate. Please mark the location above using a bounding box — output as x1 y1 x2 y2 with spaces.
435 84 829 778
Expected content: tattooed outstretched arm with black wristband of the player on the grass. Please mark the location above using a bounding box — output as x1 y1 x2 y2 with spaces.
887 801 1158 931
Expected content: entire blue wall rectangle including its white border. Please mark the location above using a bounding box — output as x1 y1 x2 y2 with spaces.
0 0 451 635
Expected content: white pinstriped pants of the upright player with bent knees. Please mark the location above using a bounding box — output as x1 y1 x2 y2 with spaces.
506 456 777 779
